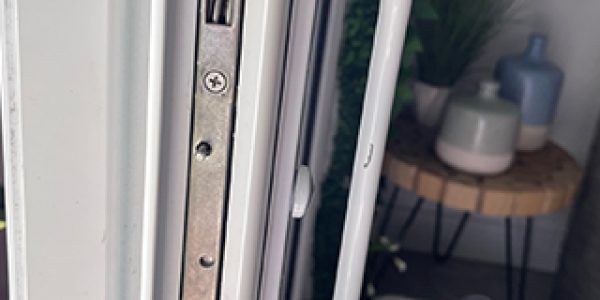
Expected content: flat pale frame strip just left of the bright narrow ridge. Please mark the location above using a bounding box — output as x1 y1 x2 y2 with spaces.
106 1 150 299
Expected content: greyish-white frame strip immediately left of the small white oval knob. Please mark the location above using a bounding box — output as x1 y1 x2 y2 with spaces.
261 0 316 300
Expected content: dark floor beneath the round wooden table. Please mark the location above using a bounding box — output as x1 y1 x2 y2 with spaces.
378 252 554 300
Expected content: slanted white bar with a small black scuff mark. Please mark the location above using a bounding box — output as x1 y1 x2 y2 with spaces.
333 0 412 300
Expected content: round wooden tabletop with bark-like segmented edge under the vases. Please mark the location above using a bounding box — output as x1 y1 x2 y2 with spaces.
382 122 582 216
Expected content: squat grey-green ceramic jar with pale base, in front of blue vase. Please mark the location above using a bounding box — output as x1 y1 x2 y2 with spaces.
436 81 520 175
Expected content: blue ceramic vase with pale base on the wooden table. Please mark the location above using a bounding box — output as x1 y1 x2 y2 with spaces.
495 34 564 151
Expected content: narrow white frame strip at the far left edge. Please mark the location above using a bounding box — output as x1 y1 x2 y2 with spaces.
0 0 28 300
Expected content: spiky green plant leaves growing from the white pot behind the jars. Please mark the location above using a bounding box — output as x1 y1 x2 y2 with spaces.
415 0 512 87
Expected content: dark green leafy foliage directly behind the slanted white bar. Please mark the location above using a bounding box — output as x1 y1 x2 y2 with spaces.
313 0 435 300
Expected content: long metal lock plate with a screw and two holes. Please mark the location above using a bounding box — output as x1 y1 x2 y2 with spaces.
182 0 242 300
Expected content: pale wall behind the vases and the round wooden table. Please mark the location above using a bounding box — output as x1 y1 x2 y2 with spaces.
398 0 600 271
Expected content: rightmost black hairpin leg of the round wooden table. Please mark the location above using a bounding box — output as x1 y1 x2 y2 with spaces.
506 217 533 300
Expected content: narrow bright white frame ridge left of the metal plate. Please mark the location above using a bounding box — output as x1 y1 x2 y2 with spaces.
140 0 166 300
